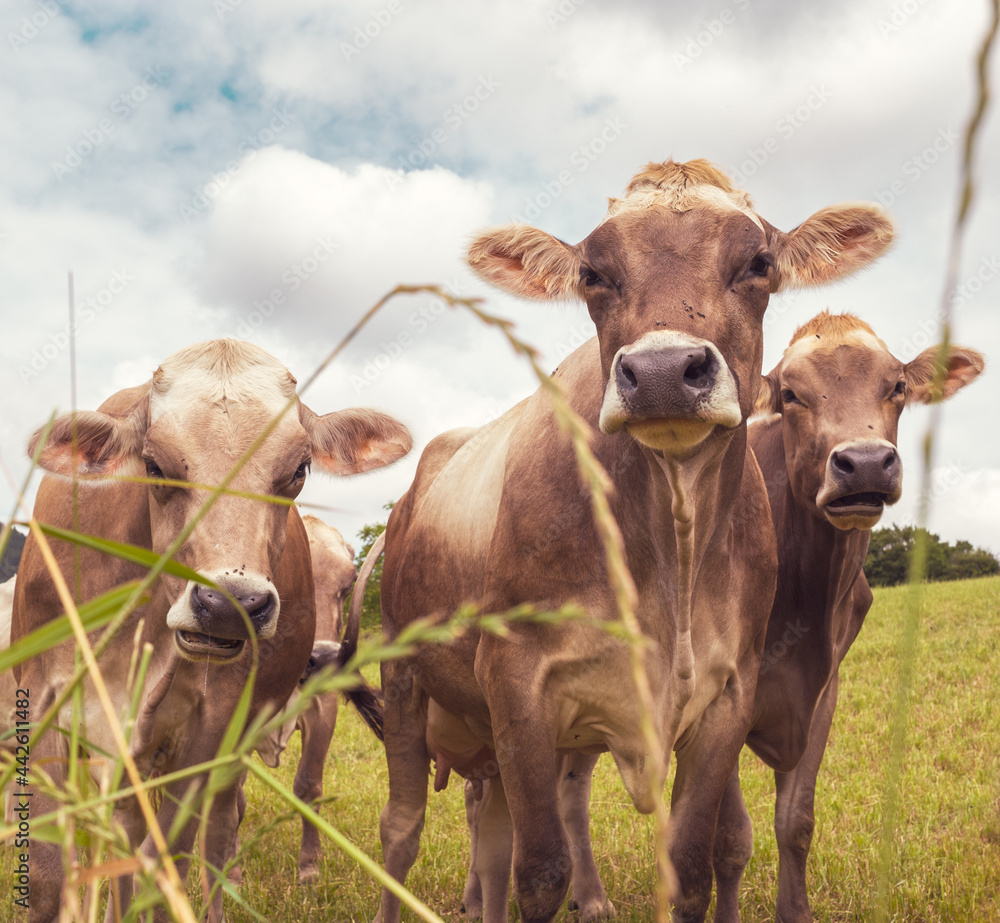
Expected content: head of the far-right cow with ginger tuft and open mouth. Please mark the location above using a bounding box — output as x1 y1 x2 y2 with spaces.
757 311 983 529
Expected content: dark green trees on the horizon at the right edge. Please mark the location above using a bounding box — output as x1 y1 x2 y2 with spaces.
865 526 1000 586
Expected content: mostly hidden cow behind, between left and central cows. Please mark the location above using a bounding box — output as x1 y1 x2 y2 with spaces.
257 515 358 884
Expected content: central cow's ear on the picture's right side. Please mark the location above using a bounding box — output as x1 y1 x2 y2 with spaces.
766 202 896 291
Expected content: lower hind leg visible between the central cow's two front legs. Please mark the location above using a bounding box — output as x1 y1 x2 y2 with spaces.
559 753 615 923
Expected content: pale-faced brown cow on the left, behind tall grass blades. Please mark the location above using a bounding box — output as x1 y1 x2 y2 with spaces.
12 340 410 921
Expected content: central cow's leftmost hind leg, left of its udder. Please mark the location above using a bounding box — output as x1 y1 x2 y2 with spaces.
375 660 430 923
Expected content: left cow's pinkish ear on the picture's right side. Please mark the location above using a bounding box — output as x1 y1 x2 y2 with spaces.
299 404 413 475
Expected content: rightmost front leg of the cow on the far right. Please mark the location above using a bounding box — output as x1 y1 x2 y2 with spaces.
774 674 839 923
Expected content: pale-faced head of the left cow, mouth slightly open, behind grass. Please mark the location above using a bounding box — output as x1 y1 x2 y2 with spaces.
30 340 411 662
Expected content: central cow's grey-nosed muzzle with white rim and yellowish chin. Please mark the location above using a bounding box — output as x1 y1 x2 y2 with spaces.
600 330 743 454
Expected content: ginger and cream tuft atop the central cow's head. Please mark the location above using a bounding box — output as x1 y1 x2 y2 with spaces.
604 160 763 227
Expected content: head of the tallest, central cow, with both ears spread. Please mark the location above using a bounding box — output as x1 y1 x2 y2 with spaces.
469 160 893 456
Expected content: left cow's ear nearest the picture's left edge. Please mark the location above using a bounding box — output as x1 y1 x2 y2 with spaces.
28 410 146 477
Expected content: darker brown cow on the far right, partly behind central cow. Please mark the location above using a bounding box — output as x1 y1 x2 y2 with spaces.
716 312 983 923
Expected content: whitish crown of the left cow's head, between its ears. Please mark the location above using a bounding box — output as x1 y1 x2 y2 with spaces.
150 340 296 420
